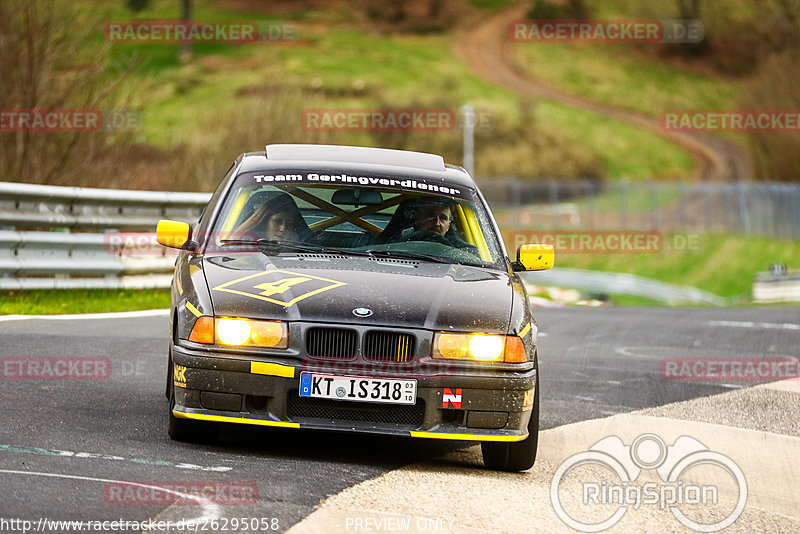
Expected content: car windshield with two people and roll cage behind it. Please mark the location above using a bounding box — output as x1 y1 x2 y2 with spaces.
206 173 503 268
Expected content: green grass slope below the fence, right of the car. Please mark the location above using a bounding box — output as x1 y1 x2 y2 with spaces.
556 234 800 303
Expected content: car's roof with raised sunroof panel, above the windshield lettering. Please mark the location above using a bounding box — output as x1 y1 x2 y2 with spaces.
237 144 476 189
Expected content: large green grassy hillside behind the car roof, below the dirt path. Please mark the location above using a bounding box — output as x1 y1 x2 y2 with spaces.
75 0 692 183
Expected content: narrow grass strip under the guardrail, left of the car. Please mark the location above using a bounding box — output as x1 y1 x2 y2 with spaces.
0 289 170 315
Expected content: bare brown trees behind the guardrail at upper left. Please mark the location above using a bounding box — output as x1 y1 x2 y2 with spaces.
0 0 134 183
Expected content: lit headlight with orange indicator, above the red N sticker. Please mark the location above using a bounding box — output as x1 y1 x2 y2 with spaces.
433 332 528 363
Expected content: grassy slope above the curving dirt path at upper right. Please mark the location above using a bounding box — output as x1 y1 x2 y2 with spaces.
515 0 754 150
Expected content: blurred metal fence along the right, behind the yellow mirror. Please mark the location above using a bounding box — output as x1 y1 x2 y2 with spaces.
478 177 800 239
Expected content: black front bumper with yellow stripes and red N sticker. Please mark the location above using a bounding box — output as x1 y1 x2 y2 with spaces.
173 346 537 442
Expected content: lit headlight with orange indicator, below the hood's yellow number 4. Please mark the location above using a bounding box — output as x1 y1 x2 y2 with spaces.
189 317 289 349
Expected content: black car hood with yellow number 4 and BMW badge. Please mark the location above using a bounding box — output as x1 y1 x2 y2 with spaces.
203 254 520 333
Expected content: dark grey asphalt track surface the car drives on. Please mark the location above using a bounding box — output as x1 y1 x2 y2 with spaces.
0 308 800 532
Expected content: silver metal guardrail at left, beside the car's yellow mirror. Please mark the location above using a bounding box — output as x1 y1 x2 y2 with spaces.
0 182 211 290
